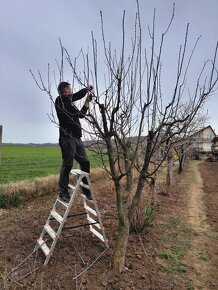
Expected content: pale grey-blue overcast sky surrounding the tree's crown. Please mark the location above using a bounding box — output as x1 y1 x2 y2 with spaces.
0 0 218 143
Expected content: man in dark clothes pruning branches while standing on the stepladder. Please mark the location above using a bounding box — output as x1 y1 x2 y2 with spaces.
55 82 93 203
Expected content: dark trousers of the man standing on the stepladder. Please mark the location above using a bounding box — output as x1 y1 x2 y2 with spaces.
59 136 90 193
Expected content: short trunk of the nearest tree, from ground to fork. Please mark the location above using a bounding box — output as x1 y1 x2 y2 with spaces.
114 218 129 273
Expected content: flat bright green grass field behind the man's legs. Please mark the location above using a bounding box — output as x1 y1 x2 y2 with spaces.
0 145 105 184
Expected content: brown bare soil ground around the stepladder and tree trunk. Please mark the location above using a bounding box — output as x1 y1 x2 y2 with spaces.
0 161 218 290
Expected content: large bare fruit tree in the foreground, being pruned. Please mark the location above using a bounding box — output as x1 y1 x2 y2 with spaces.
31 1 218 272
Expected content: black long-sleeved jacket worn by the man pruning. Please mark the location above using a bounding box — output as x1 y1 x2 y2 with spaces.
55 88 88 138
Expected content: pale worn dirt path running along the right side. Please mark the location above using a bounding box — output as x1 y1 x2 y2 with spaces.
187 164 218 289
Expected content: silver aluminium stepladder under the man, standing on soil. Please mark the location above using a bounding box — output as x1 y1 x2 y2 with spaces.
35 169 108 265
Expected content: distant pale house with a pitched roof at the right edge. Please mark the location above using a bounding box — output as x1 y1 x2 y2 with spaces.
192 126 216 153
